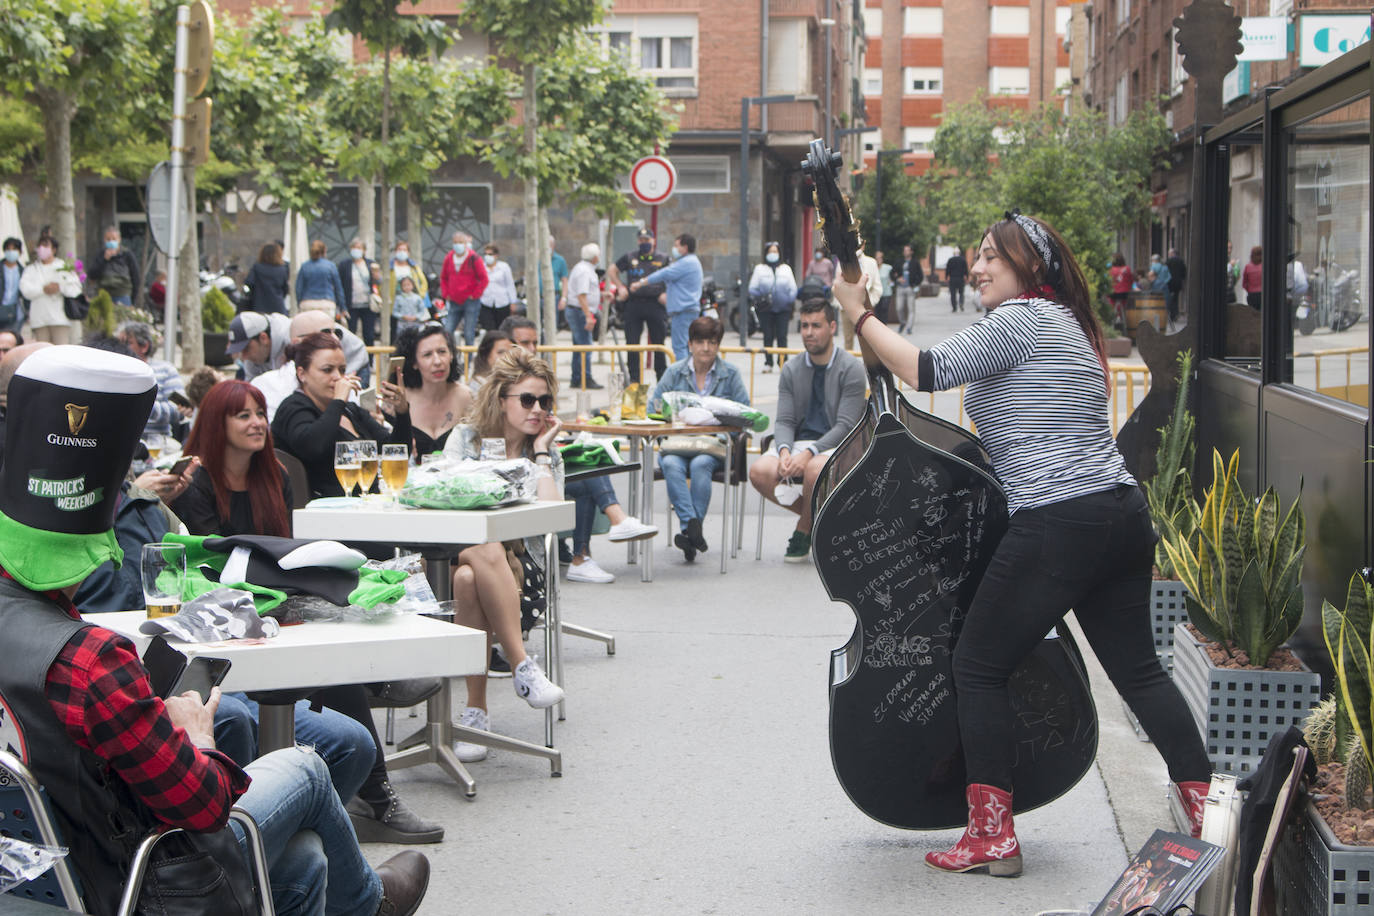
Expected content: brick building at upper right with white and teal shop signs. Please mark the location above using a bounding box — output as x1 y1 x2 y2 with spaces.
1070 0 1370 271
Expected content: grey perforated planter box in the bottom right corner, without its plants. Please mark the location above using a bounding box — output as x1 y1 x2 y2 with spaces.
1274 801 1374 916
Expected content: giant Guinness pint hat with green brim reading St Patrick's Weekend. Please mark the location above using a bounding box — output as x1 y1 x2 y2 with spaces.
0 346 157 591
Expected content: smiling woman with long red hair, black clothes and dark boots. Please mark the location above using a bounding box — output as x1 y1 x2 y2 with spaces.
170 379 444 843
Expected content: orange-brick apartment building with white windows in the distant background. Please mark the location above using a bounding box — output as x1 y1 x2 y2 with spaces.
863 0 1070 174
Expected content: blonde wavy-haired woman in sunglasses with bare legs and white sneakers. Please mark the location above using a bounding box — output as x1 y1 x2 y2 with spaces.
447 349 563 762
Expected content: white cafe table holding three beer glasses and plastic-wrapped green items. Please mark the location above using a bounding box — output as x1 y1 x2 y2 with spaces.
293 499 577 797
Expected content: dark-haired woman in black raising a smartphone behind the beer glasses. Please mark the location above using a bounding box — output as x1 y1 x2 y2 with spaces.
272 331 411 497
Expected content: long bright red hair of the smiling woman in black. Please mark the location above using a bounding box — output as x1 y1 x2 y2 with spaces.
183 379 291 537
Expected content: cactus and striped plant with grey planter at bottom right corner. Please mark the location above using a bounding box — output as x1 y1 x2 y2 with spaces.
1274 570 1374 915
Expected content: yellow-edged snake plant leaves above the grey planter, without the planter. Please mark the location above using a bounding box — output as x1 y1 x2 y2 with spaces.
1164 450 1307 667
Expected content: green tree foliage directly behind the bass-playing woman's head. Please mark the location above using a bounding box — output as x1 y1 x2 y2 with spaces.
925 99 1169 313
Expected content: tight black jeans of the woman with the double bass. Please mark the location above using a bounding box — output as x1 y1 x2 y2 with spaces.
954 485 1212 791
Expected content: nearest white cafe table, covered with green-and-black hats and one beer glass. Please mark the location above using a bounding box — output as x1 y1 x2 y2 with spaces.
85 611 486 797
